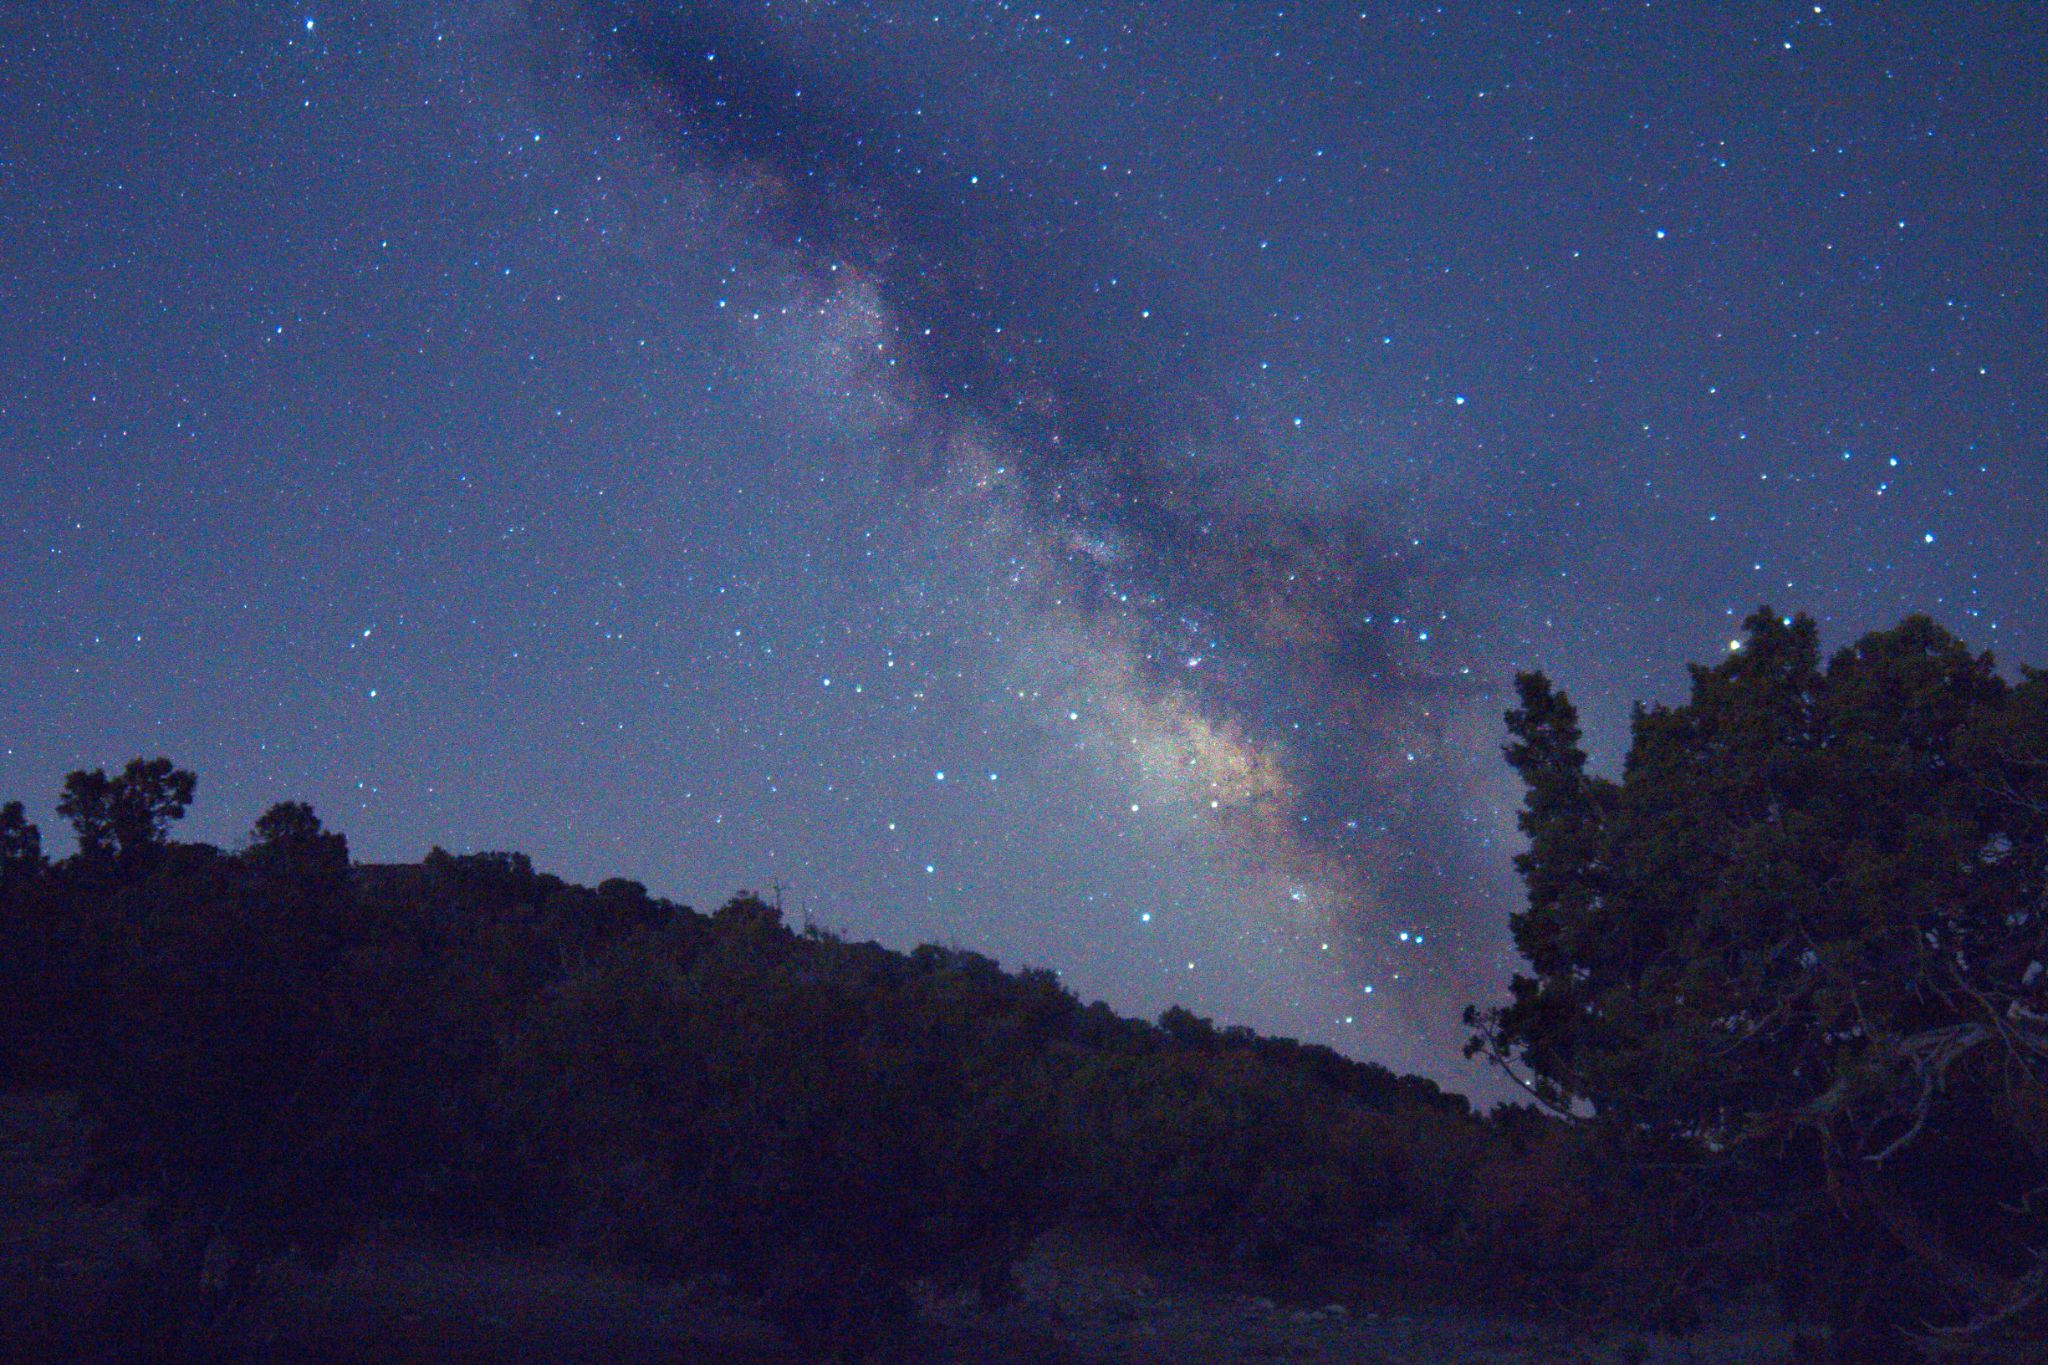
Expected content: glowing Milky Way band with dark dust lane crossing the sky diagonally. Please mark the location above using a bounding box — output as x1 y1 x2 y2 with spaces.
569 6 1515 1002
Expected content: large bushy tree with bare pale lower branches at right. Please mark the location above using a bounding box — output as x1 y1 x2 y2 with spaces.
1468 610 2048 1359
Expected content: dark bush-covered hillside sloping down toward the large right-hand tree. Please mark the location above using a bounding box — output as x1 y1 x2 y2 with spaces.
0 761 1613 1353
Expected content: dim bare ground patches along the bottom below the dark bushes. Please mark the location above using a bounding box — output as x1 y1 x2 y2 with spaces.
0 1095 1788 1365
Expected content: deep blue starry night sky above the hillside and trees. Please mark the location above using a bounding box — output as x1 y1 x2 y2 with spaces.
0 0 2048 1087
